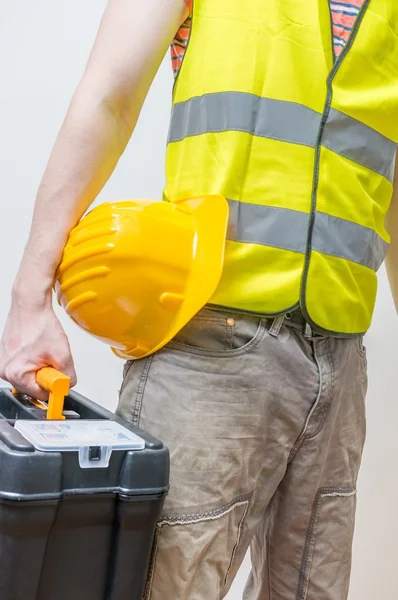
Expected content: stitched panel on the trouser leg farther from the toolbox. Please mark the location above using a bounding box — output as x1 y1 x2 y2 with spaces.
296 488 356 600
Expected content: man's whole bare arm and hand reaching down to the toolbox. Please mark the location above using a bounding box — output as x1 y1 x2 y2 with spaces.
0 0 188 398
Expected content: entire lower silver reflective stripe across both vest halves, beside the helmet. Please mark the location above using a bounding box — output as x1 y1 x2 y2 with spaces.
227 200 388 271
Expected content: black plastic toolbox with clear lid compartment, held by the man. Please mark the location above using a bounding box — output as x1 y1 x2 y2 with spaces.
0 370 169 600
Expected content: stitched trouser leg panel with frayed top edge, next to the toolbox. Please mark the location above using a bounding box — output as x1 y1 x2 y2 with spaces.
143 493 252 600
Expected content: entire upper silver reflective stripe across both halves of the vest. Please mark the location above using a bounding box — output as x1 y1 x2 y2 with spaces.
168 92 397 181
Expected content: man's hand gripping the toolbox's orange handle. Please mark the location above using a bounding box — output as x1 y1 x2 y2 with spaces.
0 297 76 400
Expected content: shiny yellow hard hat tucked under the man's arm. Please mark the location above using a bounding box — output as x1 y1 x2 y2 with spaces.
55 196 228 359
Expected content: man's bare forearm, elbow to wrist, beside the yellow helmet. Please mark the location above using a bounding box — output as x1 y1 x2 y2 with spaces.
14 97 131 299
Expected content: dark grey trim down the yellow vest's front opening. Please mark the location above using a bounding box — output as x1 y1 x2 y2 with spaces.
300 0 371 337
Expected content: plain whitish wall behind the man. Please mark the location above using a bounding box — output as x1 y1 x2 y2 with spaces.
0 0 398 600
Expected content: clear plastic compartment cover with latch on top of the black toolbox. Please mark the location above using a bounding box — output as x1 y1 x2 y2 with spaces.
15 419 145 469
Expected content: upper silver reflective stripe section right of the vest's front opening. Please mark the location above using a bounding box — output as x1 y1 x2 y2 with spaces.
322 108 397 181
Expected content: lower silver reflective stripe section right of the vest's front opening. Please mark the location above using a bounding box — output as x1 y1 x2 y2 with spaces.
312 212 388 271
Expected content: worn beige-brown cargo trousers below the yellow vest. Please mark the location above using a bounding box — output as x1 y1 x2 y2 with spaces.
118 310 367 600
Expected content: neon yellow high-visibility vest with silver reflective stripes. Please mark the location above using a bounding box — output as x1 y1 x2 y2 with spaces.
165 0 398 335
